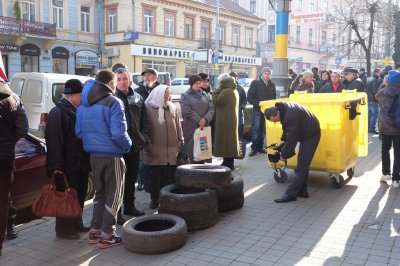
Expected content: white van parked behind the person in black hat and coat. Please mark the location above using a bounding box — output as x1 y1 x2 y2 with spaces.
10 72 91 137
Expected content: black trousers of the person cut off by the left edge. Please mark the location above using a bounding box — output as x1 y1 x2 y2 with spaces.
0 158 14 250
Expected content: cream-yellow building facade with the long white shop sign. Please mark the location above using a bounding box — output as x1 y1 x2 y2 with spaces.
102 0 262 78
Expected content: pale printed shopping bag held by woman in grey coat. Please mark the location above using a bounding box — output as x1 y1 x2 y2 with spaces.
193 127 212 162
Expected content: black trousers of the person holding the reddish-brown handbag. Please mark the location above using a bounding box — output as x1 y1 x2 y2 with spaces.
55 171 89 234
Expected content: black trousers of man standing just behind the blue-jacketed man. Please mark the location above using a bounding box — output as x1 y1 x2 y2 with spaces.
123 151 140 209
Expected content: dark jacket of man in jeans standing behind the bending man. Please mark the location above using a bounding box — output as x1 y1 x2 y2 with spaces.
247 78 276 111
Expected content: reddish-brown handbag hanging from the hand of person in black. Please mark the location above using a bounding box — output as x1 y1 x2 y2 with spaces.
32 173 82 218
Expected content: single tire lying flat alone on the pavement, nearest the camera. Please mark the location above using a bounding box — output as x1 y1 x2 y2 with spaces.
121 214 187 254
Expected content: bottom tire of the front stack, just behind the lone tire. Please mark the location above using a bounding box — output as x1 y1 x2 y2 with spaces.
158 207 218 232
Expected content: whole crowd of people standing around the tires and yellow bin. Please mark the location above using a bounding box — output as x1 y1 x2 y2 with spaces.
0 60 400 254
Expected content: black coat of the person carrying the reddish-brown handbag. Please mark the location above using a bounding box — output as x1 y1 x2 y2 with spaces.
45 98 90 177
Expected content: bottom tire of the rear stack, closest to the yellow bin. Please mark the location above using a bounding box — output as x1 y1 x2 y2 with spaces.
216 176 244 212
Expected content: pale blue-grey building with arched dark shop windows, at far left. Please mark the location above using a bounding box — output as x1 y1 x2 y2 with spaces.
0 0 101 78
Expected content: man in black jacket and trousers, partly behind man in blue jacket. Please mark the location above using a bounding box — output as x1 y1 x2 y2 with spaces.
114 68 150 225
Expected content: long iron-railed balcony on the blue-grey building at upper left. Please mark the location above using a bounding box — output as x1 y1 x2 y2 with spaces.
0 16 56 38
